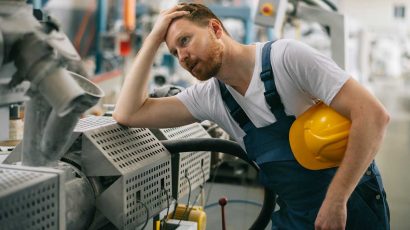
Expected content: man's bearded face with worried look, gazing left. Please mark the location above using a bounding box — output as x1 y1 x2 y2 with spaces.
165 19 223 81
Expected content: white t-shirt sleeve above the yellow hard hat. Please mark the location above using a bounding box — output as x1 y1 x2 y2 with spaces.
283 39 350 105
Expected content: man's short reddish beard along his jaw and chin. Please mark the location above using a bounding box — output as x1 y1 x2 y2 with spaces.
190 34 223 81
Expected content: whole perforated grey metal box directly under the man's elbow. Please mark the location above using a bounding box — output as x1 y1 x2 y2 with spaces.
76 121 172 229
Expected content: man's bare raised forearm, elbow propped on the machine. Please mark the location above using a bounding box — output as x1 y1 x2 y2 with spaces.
114 36 161 123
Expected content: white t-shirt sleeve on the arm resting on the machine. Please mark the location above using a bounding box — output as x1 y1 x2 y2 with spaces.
176 81 215 121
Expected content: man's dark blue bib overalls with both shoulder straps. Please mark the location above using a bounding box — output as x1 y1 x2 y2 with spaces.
219 42 390 230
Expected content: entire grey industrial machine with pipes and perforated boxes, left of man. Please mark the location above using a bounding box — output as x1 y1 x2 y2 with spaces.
0 1 209 229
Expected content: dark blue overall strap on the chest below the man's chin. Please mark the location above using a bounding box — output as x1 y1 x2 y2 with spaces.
218 80 251 130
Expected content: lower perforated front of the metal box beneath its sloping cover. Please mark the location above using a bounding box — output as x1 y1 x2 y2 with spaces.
97 158 171 229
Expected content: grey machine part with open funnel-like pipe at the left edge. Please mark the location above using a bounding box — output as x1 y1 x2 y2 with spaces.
0 1 103 229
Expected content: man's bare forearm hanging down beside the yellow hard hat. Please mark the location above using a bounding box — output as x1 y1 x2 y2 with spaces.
326 107 389 204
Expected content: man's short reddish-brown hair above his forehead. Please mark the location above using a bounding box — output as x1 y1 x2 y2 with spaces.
178 3 229 36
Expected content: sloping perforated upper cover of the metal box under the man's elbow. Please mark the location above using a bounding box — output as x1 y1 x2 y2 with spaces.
82 124 170 176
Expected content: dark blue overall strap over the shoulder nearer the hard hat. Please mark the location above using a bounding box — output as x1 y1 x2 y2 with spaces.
260 41 287 121
